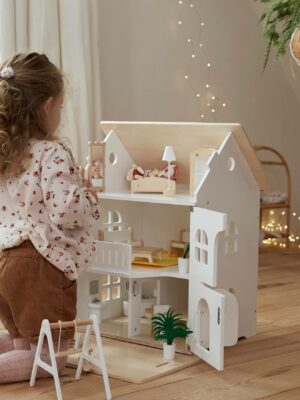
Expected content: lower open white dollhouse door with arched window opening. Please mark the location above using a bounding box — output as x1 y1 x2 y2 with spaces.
188 284 225 371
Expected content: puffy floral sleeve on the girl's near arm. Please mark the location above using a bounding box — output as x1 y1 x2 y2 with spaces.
41 143 100 229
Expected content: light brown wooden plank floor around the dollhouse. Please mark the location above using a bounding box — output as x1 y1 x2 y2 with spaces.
0 253 300 400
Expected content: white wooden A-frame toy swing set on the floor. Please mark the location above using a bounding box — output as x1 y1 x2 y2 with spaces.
30 314 112 400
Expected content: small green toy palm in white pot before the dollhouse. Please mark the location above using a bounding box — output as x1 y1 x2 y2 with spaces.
151 308 192 361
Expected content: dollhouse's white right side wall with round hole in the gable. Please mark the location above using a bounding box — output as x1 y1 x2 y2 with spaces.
197 135 260 337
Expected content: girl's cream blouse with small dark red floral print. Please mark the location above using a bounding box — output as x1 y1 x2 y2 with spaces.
0 140 100 280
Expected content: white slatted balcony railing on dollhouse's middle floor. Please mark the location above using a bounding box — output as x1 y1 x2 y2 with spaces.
93 241 131 275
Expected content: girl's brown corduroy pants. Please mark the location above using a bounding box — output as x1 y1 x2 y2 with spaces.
0 240 77 341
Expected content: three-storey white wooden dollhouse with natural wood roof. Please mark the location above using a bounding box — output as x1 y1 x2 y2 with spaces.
78 122 268 370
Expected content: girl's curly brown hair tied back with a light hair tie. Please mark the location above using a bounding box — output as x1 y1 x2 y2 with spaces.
0 53 64 175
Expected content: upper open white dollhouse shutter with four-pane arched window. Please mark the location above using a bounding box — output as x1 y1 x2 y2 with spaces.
190 207 227 286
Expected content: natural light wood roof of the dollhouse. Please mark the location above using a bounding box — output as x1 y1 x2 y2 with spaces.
100 121 269 190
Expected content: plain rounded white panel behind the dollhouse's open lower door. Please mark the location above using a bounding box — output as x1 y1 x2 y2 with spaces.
216 289 239 346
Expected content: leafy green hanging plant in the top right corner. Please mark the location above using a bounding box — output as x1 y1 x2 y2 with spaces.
259 0 300 70
